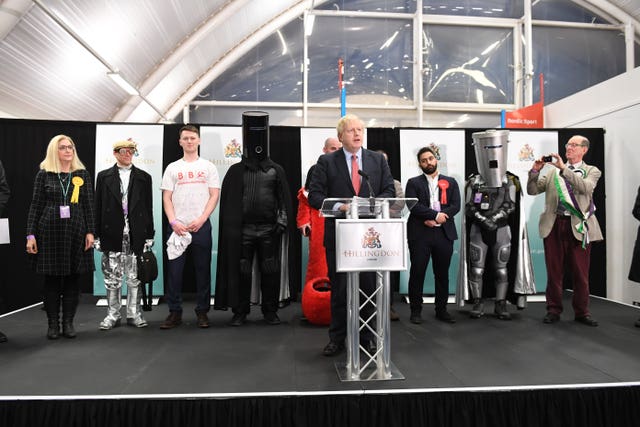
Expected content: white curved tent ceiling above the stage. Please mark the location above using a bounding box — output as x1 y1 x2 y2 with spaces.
0 0 640 122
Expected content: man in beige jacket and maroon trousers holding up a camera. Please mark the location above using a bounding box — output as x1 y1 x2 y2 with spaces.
527 135 603 326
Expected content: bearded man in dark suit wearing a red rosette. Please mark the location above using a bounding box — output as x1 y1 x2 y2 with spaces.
404 147 460 324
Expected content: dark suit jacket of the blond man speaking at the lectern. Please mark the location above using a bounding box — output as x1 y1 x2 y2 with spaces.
308 148 396 249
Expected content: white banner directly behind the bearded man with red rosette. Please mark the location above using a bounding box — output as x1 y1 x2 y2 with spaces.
400 129 465 294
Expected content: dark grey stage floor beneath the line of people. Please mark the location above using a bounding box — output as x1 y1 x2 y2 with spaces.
0 294 640 399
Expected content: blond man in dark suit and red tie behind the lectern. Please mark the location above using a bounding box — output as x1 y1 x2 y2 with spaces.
309 114 395 356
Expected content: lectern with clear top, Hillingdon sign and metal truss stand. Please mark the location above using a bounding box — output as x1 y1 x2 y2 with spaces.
320 197 418 381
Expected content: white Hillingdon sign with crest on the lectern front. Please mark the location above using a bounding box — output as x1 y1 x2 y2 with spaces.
336 219 408 272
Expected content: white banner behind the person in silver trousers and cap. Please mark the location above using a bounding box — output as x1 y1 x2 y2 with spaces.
93 124 166 296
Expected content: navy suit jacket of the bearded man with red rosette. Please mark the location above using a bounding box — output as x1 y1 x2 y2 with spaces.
404 174 460 241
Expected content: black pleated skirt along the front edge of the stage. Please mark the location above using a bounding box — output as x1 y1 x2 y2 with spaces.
0 387 640 427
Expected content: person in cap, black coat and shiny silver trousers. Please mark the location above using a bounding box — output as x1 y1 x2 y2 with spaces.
94 139 154 331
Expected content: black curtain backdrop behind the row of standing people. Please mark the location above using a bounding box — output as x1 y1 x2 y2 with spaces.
0 119 606 312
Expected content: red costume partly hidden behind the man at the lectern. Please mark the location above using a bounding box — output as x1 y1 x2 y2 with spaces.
296 187 331 325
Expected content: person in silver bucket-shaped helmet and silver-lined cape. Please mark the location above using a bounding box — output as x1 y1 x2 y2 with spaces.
456 130 535 320
